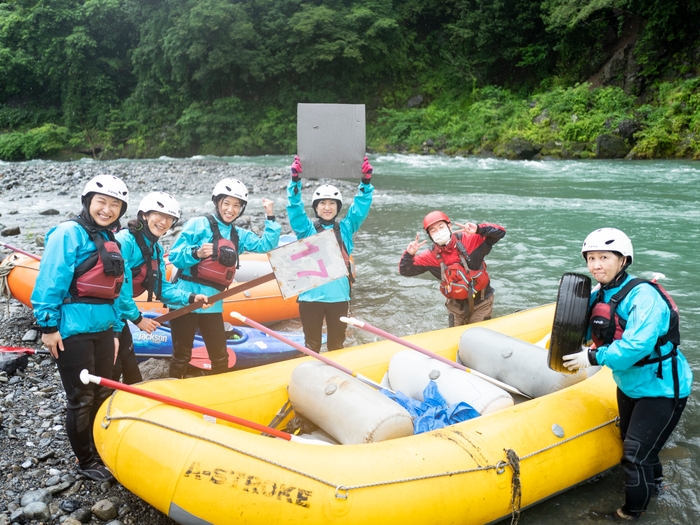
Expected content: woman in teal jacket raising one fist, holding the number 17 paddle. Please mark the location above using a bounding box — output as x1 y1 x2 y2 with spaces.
167 179 281 378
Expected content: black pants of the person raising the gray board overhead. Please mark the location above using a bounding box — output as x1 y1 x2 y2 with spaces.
299 301 348 352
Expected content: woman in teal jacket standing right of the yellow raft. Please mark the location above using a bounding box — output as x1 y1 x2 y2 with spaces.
564 228 693 520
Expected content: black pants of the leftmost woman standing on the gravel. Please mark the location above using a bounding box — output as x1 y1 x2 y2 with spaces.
56 328 114 467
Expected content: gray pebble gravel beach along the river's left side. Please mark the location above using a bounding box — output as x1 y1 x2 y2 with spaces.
0 160 356 525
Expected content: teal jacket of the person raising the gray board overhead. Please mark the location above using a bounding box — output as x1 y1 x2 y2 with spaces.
287 180 374 303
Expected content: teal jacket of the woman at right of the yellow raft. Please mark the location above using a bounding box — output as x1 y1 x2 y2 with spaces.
589 276 693 399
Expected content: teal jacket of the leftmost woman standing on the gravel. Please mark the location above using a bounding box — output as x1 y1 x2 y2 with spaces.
31 221 122 339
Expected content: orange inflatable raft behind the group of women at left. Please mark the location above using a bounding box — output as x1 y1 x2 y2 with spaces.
2 253 299 324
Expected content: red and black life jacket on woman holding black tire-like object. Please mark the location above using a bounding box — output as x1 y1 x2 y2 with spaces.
590 279 681 400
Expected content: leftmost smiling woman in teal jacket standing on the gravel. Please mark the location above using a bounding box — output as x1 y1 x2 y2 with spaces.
31 175 129 482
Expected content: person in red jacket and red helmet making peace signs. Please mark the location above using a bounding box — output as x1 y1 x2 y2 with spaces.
399 211 506 327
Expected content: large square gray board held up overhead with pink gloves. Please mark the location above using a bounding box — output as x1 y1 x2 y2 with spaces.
297 104 365 179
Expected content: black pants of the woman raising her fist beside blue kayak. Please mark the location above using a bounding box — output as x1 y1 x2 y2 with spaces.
170 312 228 379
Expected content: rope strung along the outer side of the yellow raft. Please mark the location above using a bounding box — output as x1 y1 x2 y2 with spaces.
102 390 620 504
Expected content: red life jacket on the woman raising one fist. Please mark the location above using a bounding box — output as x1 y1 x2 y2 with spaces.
180 214 239 291
